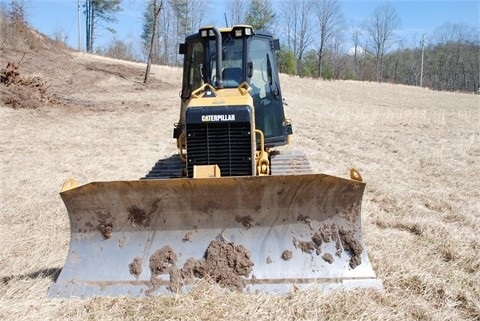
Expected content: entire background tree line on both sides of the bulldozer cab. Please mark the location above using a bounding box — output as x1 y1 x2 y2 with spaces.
4 0 480 93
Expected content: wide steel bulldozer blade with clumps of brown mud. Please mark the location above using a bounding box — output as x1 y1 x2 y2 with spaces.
48 174 382 297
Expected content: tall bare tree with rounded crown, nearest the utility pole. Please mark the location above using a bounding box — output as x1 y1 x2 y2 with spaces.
366 3 400 82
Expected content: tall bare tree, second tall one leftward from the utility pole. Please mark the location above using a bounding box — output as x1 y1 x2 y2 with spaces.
314 0 344 77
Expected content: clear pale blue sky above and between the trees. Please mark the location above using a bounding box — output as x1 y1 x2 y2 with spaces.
6 0 480 49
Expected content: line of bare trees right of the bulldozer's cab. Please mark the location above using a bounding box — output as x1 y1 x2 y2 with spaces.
278 0 480 93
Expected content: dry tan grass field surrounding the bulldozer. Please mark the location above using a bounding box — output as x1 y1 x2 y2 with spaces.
0 46 480 320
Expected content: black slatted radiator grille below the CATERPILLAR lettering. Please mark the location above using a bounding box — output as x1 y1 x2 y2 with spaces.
187 122 252 177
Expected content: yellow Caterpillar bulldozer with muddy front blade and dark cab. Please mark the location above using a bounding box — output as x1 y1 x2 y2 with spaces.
48 25 382 297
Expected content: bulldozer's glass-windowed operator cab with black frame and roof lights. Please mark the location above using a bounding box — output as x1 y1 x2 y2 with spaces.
180 25 292 147
